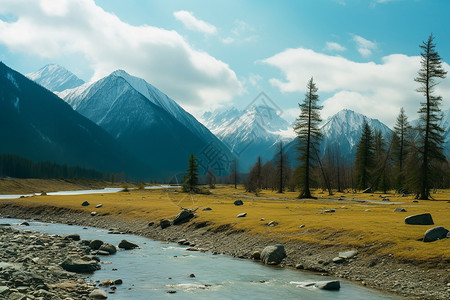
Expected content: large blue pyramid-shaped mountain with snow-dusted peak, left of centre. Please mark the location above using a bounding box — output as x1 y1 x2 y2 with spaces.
58 70 232 178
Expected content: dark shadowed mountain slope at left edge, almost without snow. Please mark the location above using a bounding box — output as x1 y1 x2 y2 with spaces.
0 63 137 172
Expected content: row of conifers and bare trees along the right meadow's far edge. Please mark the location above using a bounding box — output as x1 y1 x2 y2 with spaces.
244 34 450 199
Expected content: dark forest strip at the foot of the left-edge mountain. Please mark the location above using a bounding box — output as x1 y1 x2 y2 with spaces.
0 154 103 179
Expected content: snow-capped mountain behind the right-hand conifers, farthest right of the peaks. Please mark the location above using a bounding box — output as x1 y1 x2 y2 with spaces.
286 109 392 166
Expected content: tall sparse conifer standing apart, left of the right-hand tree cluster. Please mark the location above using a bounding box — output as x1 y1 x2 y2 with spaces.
294 77 322 198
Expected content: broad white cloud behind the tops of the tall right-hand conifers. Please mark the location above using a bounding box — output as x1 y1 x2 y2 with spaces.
263 48 450 126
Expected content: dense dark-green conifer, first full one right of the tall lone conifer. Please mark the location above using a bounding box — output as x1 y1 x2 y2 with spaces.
355 120 374 190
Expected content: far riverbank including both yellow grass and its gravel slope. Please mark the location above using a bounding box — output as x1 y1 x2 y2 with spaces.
0 186 450 299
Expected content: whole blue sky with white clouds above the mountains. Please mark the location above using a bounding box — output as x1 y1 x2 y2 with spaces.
0 0 450 126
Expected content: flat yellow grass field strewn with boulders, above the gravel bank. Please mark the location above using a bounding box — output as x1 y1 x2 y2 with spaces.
0 185 450 264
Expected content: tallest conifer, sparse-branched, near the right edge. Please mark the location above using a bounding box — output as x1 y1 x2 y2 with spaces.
415 34 447 200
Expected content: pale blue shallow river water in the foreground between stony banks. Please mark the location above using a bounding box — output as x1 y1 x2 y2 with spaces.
0 219 401 300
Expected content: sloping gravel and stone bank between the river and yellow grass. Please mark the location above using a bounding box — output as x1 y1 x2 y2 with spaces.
1 203 450 299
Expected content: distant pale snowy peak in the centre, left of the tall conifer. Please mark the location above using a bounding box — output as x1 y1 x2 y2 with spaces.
202 104 295 172
